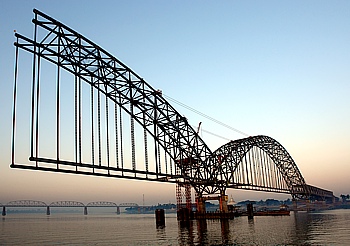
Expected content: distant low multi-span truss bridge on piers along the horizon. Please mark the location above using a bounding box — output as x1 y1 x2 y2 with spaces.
0 200 142 216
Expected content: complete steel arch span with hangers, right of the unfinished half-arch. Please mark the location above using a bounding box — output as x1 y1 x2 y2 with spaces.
209 136 308 198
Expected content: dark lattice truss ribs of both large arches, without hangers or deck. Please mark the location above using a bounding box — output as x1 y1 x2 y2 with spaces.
11 10 334 200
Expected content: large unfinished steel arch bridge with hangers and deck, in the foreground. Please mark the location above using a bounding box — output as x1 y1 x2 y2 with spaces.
11 9 333 212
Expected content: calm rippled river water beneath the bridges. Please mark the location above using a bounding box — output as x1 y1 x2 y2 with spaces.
0 210 350 245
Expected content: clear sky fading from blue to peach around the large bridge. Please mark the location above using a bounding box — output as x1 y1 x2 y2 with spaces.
0 0 350 204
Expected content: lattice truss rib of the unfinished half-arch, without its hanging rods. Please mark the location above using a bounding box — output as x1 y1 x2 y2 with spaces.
15 10 219 194
